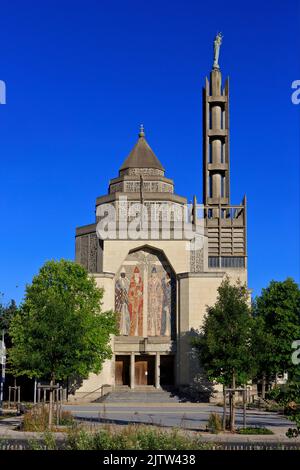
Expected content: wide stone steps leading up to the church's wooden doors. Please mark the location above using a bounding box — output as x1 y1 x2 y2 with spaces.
99 387 181 403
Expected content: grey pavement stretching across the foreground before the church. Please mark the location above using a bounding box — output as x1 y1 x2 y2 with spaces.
0 403 300 448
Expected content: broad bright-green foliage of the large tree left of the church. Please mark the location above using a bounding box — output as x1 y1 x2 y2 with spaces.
8 260 117 380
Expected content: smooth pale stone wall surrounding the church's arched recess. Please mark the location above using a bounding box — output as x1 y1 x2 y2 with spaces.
71 240 247 401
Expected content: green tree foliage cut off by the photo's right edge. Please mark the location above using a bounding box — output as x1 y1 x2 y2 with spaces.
253 278 300 383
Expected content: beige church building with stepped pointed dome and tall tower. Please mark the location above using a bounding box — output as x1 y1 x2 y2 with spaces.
75 54 247 401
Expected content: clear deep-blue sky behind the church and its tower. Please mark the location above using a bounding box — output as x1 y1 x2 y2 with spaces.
0 0 300 302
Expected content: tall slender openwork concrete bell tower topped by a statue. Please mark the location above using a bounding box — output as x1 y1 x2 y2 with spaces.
203 33 247 269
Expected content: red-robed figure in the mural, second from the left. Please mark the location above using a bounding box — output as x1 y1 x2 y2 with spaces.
128 266 143 336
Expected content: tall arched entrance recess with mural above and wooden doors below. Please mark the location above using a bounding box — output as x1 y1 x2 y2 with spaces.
114 247 176 388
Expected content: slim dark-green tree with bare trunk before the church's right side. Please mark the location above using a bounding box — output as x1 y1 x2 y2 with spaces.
193 277 253 430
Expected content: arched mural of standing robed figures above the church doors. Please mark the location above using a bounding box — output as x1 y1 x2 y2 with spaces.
115 250 176 337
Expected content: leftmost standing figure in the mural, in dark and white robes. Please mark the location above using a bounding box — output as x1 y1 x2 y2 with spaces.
115 268 130 336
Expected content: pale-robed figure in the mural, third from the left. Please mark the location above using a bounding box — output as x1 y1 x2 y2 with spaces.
148 266 163 336
